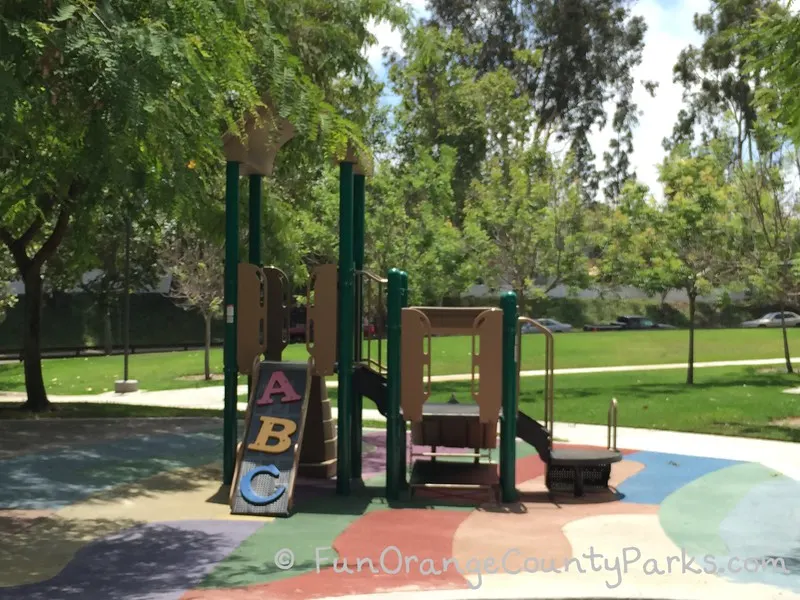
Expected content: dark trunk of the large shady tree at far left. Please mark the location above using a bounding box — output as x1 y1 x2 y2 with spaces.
22 265 50 412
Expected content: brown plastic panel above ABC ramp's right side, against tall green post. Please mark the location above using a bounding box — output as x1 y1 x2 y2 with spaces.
306 265 339 376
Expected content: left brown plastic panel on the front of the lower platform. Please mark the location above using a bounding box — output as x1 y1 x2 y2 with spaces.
400 308 431 423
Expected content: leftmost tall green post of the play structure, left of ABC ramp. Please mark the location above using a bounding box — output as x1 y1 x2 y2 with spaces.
222 161 239 484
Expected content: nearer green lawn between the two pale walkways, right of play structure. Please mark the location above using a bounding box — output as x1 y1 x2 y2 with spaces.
318 367 800 445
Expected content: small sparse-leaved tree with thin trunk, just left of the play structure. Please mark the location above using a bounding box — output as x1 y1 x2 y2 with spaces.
161 231 225 381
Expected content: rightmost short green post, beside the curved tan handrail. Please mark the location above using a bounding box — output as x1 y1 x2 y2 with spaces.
500 292 518 502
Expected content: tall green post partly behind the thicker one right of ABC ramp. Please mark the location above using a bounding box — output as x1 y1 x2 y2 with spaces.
350 175 366 479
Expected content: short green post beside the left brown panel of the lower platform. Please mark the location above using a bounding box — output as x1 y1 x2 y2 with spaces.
386 269 405 500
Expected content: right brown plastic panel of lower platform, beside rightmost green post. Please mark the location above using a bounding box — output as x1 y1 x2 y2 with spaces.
472 308 503 423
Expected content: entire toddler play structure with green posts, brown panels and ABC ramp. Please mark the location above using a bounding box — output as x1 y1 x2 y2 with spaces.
223 111 621 516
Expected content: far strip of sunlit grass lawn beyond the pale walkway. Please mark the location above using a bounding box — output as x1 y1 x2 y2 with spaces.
0 329 800 395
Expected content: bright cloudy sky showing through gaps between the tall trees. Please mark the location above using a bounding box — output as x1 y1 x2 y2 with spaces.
367 0 709 199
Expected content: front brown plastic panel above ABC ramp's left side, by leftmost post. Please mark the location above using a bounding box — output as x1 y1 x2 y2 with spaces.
236 263 267 375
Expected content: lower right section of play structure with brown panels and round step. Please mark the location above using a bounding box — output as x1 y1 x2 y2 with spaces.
387 294 622 500
